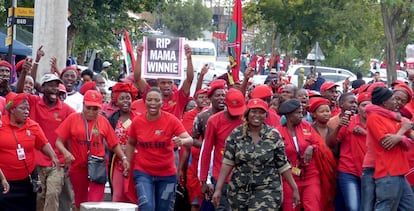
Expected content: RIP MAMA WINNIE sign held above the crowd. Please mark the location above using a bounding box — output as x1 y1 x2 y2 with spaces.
142 36 184 79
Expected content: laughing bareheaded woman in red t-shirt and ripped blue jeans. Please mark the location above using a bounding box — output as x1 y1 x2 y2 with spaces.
126 88 193 211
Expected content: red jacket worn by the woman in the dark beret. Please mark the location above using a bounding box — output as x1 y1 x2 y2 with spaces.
277 121 321 185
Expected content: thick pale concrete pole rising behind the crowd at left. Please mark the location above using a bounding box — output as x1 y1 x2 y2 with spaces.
32 0 69 81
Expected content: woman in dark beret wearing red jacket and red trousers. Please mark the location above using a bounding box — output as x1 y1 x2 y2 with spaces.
277 99 322 211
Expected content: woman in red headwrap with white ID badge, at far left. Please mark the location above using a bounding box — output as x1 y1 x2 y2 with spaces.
0 93 59 211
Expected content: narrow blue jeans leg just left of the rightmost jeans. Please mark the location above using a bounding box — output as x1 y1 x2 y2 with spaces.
361 168 375 211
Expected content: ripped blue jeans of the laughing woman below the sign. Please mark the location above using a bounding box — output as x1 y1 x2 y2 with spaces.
134 170 177 211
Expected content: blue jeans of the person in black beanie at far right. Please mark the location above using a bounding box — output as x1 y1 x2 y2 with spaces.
375 175 414 211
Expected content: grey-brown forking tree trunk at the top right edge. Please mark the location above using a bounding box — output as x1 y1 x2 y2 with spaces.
381 0 414 84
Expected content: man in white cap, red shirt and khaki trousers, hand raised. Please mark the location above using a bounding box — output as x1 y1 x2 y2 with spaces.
16 69 75 210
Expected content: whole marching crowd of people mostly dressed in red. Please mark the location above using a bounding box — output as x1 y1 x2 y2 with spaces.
0 40 414 211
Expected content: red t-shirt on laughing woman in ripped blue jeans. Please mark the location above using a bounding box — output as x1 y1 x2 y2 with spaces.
129 111 186 176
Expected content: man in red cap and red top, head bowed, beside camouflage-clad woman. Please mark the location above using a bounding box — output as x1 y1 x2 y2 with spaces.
199 89 246 210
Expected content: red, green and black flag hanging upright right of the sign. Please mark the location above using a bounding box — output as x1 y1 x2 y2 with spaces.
228 0 243 82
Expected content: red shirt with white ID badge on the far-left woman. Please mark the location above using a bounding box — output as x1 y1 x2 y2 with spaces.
0 115 47 181
